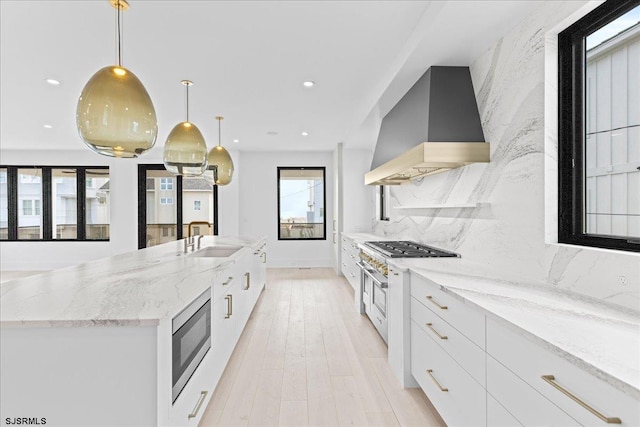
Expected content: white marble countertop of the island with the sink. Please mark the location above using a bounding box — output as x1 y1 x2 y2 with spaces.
0 236 264 328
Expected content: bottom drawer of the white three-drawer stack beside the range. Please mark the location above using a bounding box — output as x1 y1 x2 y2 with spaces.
411 321 486 427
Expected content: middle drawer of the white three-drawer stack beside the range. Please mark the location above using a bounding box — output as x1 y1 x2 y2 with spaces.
411 297 485 387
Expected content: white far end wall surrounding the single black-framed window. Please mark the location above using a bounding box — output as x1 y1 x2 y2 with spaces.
239 151 333 267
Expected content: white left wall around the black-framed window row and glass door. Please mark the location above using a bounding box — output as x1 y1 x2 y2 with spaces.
0 149 241 271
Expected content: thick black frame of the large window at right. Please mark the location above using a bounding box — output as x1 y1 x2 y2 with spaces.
558 0 640 252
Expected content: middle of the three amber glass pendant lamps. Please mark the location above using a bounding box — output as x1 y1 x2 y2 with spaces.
164 80 207 176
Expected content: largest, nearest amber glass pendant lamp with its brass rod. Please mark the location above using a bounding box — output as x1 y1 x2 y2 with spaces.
76 0 158 158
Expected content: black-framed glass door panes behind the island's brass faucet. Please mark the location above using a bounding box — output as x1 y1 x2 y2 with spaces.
138 164 218 249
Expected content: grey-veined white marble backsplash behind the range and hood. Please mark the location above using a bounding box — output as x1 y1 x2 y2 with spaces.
373 2 640 310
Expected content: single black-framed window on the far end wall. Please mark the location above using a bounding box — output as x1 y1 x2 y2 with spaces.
278 167 327 240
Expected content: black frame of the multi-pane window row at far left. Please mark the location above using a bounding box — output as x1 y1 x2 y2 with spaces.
0 165 111 242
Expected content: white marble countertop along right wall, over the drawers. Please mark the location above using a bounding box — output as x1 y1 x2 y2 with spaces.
390 259 640 399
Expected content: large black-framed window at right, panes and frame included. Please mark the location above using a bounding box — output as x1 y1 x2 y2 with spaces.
558 0 640 252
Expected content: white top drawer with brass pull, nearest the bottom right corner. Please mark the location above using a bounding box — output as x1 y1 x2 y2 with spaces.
487 319 640 426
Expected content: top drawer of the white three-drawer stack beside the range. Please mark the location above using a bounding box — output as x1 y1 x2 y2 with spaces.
411 274 485 349
